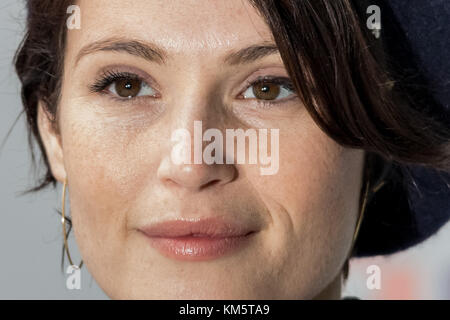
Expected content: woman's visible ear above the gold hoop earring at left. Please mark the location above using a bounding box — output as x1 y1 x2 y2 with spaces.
37 101 66 183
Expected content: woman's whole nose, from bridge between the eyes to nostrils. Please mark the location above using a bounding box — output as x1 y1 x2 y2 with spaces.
157 70 237 191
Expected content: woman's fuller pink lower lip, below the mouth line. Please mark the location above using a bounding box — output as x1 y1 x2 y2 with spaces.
148 233 254 261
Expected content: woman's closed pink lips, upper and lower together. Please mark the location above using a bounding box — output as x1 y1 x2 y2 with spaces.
140 218 255 261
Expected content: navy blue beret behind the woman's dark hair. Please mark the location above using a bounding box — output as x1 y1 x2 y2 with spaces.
353 0 450 257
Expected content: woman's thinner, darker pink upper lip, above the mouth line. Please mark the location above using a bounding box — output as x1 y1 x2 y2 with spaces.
139 217 256 238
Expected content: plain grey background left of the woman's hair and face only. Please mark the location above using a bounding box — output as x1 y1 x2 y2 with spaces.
0 0 107 299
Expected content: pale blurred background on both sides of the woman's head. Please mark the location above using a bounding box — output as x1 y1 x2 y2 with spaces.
0 0 450 299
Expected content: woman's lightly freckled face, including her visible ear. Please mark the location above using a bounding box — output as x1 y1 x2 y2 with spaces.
39 0 363 299
